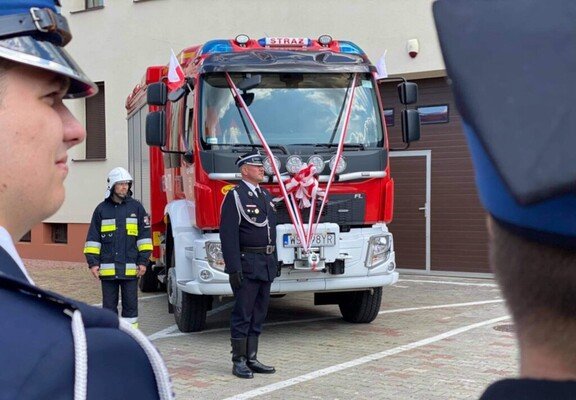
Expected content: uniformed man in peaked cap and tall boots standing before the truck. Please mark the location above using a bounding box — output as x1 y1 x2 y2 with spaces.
220 150 277 378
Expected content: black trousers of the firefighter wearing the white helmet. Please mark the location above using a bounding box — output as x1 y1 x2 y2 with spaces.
101 279 138 318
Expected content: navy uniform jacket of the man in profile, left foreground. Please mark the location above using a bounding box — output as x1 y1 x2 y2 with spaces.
0 248 168 400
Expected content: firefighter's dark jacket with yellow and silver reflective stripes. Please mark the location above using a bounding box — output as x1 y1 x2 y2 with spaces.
84 197 152 279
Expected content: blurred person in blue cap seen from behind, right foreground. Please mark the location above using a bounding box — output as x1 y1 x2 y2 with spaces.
433 0 576 400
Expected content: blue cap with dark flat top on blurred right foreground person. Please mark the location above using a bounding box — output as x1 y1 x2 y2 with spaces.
433 0 576 248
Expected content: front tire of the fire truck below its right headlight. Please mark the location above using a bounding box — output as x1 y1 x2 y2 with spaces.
338 287 382 324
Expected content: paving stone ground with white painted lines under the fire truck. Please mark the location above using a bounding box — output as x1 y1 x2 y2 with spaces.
24 260 518 400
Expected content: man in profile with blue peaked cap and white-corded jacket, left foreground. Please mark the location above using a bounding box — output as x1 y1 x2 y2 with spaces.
0 0 173 400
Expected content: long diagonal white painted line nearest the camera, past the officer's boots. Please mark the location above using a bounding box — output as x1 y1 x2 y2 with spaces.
224 316 510 400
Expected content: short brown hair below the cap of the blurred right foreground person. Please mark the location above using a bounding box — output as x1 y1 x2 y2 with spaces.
490 218 576 368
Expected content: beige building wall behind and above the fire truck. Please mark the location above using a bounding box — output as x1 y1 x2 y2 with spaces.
21 0 444 259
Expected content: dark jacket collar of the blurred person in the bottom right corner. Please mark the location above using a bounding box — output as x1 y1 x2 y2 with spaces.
480 379 576 400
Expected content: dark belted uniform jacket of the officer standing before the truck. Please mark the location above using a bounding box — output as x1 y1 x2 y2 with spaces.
220 182 277 281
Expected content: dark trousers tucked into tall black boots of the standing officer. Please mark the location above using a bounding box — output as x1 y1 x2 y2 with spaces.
230 278 272 339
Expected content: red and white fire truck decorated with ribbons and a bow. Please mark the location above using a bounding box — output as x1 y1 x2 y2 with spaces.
126 35 420 332
